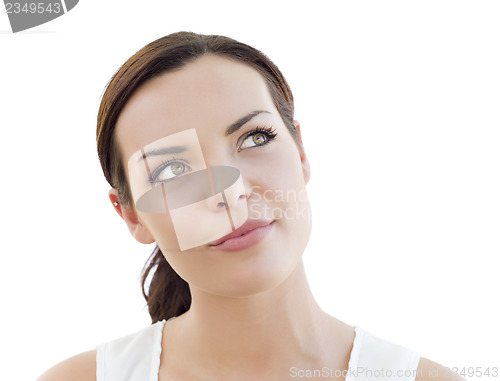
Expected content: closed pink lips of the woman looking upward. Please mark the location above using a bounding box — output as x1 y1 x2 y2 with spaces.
210 220 274 251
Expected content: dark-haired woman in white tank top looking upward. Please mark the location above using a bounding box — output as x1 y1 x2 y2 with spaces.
40 32 461 380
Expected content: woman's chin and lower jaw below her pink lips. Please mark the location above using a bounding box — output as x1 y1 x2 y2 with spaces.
169 220 310 297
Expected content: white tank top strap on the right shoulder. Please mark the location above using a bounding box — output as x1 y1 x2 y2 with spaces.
346 327 420 381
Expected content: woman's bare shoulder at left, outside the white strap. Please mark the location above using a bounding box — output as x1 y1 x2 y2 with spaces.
37 350 97 381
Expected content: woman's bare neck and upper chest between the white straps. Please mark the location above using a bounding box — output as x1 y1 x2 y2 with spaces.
160 266 354 380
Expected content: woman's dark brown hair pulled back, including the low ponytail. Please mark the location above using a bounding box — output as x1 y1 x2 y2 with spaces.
97 32 301 323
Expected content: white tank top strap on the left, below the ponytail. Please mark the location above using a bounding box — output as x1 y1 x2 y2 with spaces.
96 320 165 381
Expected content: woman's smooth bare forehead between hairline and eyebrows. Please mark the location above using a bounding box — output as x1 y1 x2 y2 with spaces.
115 55 278 153
